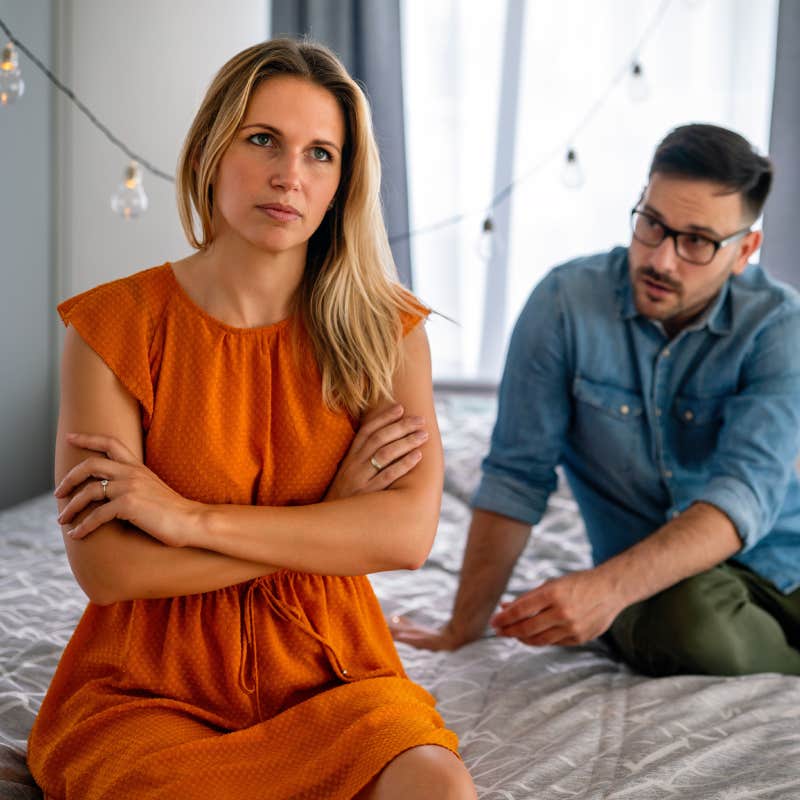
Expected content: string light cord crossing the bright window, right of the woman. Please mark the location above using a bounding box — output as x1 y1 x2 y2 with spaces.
389 0 673 244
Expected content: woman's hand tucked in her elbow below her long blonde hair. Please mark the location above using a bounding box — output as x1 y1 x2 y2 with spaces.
325 405 428 500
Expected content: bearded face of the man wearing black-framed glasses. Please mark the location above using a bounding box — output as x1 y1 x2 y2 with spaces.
628 172 761 336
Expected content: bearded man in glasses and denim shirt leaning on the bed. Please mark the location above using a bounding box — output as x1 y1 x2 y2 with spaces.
395 125 800 675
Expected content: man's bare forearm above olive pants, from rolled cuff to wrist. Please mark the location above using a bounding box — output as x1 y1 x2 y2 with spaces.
596 503 742 607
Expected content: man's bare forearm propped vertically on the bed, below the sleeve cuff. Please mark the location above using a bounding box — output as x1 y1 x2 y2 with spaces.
447 509 531 645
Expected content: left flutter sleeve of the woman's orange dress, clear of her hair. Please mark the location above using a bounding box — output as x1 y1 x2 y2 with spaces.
58 267 170 427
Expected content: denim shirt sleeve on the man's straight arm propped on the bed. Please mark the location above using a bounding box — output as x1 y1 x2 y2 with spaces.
472 270 570 525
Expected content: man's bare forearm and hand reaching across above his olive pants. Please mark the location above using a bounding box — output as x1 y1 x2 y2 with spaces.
491 503 742 645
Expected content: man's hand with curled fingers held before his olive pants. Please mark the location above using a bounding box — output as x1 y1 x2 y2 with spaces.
490 568 627 645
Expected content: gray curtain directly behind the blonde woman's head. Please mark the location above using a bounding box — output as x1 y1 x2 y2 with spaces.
272 0 412 288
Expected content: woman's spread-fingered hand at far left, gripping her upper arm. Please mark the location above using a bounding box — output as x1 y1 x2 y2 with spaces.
54 433 200 547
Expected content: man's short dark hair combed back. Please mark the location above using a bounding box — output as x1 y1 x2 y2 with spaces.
650 124 772 222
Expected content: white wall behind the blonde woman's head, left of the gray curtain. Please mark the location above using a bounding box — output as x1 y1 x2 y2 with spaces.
56 0 270 298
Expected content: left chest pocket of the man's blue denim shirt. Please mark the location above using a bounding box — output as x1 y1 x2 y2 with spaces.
571 377 645 472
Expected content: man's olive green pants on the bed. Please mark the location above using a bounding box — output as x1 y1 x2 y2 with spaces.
604 561 800 676
